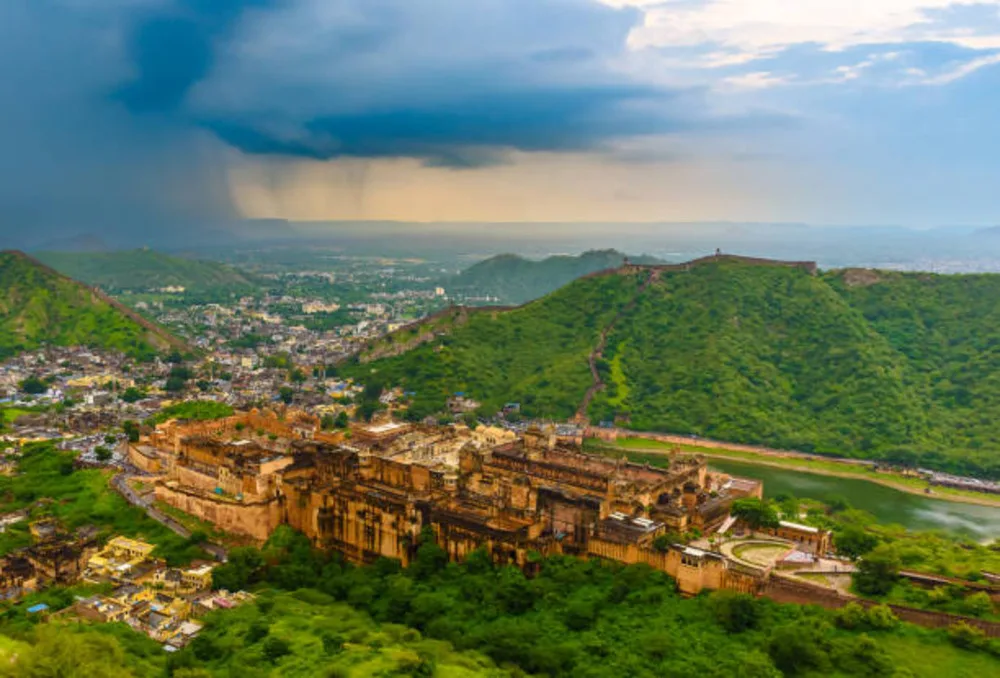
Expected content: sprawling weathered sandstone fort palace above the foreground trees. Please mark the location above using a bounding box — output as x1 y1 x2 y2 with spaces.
130 412 761 566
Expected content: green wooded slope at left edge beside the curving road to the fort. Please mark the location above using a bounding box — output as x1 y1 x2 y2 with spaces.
0 443 207 563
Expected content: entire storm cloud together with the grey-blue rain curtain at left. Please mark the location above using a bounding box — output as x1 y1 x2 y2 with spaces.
0 0 710 246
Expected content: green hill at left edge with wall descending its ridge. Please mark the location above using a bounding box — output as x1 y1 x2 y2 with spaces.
0 251 186 357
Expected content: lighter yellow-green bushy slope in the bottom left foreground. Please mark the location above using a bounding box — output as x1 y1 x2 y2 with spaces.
0 590 510 678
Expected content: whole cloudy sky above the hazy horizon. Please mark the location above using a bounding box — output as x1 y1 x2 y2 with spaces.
0 0 1000 245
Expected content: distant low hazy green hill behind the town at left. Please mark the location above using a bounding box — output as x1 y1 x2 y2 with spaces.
37 249 258 293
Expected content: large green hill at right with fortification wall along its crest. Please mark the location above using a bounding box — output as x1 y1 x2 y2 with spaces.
346 257 1000 477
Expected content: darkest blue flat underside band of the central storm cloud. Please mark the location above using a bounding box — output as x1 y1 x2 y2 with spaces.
208 86 679 168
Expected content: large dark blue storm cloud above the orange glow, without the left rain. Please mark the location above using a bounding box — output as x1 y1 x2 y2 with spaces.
109 0 691 167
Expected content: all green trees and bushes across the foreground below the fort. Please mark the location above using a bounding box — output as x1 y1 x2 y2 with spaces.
0 528 1000 678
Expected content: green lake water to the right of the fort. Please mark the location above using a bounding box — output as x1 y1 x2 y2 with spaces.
709 459 1000 541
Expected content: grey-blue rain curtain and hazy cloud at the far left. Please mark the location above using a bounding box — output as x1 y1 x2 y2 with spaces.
0 0 241 248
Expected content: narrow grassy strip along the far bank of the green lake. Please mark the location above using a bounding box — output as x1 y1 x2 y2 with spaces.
588 438 1000 508
